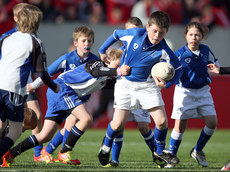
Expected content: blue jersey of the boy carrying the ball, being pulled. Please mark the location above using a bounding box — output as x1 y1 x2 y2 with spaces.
99 28 181 88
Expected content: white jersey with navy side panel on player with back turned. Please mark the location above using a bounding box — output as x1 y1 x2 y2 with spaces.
0 31 49 96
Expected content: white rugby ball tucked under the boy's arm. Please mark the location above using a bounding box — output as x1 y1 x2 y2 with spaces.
151 62 175 81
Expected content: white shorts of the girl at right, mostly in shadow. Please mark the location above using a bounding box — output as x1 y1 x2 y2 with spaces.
171 85 216 119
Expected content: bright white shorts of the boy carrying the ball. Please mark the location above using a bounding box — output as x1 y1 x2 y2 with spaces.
114 77 164 110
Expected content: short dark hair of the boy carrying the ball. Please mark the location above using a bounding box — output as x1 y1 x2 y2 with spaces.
148 11 170 29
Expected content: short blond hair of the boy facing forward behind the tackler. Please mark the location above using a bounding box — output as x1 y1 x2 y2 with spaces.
73 26 94 42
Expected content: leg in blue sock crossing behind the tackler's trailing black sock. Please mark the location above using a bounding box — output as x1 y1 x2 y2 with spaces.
26 92 44 161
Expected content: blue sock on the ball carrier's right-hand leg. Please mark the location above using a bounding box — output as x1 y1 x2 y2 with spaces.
154 127 168 154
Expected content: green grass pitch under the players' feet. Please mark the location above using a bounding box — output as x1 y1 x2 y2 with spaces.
0 129 230 172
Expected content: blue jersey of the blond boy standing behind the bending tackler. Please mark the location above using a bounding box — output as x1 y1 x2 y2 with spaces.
48 50 99 76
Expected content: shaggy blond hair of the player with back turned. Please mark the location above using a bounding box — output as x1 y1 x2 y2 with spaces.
17 5 43 33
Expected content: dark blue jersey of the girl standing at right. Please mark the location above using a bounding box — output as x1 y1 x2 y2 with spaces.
175 44 219 89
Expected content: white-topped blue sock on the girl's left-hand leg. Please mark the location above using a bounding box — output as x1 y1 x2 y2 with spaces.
169 129 184 156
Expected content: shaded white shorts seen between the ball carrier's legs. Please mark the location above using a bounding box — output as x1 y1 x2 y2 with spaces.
128 109 151 123
